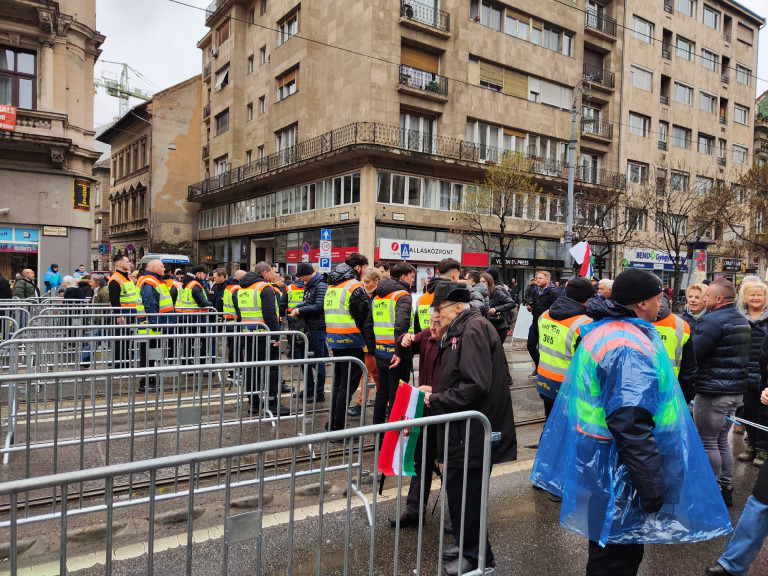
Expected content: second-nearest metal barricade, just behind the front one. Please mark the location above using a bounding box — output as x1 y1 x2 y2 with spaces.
0 352 367 479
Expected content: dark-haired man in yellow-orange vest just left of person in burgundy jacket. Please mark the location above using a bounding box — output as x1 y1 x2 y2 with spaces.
371 262 416 424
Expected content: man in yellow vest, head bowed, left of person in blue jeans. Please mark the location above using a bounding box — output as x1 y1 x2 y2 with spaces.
236 262 290 416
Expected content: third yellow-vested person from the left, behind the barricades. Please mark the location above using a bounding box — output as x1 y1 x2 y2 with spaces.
175 266 213 364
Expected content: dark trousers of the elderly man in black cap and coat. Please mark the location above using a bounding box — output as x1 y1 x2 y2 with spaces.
445 466 493 566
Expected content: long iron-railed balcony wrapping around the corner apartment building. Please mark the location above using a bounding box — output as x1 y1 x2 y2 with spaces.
188 122 626 201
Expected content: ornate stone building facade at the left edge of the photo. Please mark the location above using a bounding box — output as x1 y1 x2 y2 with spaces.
0 0 105 281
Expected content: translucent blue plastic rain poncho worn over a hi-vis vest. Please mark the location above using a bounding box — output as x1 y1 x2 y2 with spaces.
531 312 731 546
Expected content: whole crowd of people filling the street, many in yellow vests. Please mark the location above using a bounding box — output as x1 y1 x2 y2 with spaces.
6 252 768 576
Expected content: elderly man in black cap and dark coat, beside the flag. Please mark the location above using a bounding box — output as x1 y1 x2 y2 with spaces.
420 282 517 576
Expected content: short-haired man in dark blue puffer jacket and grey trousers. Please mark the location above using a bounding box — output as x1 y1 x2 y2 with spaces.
693 280 752 506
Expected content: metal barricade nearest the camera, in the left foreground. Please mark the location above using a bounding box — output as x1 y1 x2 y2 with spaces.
0 412 492 576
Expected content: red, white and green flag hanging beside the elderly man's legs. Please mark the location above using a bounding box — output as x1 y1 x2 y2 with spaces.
379 380 424 476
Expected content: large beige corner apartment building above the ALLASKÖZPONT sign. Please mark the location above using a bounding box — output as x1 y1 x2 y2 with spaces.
188 0 758 281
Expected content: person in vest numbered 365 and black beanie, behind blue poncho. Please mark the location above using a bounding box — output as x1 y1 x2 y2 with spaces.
536 278 595 418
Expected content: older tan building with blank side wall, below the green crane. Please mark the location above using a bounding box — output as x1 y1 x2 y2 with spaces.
98 76 202 262
